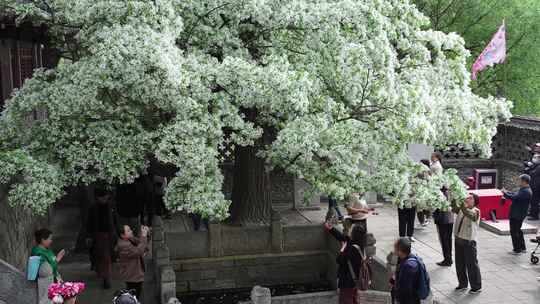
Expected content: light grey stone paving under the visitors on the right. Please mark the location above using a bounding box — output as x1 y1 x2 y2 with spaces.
302 206 540 304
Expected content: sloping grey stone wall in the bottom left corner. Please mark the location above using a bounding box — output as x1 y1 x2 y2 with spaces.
0 259 37 304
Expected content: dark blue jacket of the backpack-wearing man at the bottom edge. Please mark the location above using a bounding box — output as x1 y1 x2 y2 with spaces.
393 254 420 304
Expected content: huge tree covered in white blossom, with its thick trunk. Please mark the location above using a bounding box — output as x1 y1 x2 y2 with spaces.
0 0 510 223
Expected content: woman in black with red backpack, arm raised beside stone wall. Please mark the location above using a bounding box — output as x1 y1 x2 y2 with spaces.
324 223 366 304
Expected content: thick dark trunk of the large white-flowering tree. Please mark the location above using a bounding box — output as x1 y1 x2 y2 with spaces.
230 110 272 225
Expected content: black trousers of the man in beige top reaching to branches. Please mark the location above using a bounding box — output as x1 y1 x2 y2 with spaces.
455 238 482 289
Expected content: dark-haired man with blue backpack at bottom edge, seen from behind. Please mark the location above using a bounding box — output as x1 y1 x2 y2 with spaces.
390 237 420 304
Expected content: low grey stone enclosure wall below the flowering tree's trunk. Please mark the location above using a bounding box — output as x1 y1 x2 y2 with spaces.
171 217 378 294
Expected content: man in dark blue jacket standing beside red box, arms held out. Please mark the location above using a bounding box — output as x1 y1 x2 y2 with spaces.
502 174 532 254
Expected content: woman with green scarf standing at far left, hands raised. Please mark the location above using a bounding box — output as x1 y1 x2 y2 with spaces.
30 229 66 304
